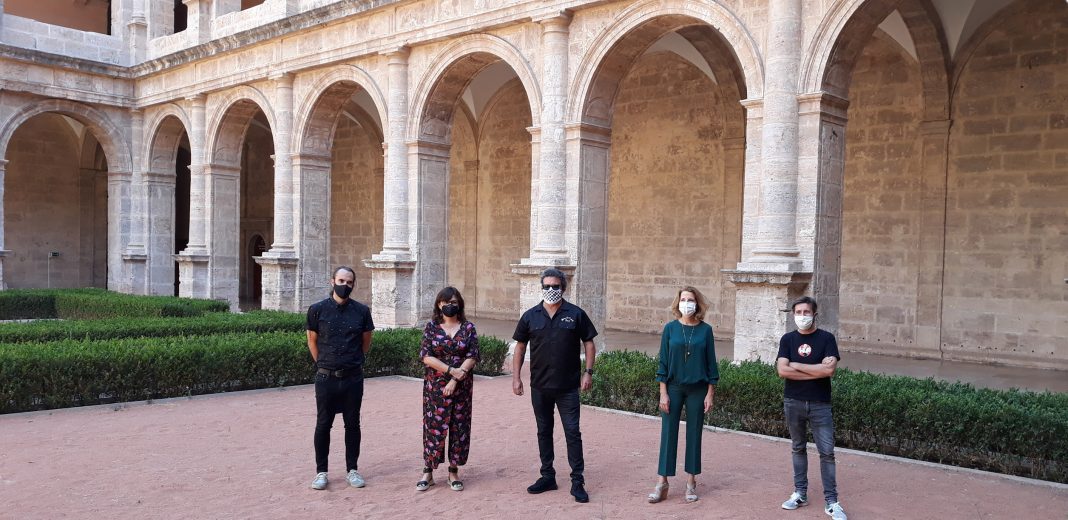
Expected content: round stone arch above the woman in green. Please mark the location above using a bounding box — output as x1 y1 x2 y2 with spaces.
566 0 764 125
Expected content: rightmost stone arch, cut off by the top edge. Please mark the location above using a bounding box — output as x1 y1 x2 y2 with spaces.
799 0 949 121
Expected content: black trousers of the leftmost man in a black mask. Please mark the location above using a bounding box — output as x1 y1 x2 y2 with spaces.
314 374 363 473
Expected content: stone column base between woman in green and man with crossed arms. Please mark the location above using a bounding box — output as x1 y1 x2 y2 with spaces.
722 271 812 364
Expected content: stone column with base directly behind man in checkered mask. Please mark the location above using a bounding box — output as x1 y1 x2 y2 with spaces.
512 13 576 313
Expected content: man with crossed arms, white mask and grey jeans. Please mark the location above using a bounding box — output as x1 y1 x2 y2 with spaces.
775 296 846 520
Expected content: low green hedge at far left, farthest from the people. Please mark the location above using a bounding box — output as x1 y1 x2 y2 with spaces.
0 288 230 320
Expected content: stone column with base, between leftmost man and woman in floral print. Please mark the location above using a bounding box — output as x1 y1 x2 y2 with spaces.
364 47 416 327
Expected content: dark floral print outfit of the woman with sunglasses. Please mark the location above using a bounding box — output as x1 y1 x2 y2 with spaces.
419 320 478 469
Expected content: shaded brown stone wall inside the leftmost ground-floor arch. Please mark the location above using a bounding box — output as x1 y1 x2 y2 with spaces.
3 114 107 288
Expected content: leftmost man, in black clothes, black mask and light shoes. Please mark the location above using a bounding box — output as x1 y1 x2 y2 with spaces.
307 267 375 489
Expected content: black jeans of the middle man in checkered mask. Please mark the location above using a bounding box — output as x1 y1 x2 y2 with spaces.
531 389 585 483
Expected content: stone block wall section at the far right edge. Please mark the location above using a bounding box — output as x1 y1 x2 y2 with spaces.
942 2 1068 368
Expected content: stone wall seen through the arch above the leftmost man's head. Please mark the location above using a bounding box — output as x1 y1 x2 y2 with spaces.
331 104 383 302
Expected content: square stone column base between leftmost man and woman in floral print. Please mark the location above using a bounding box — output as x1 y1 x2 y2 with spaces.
363 254 418 328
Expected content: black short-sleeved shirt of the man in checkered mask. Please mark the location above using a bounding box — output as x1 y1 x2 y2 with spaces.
512 301 597 390
